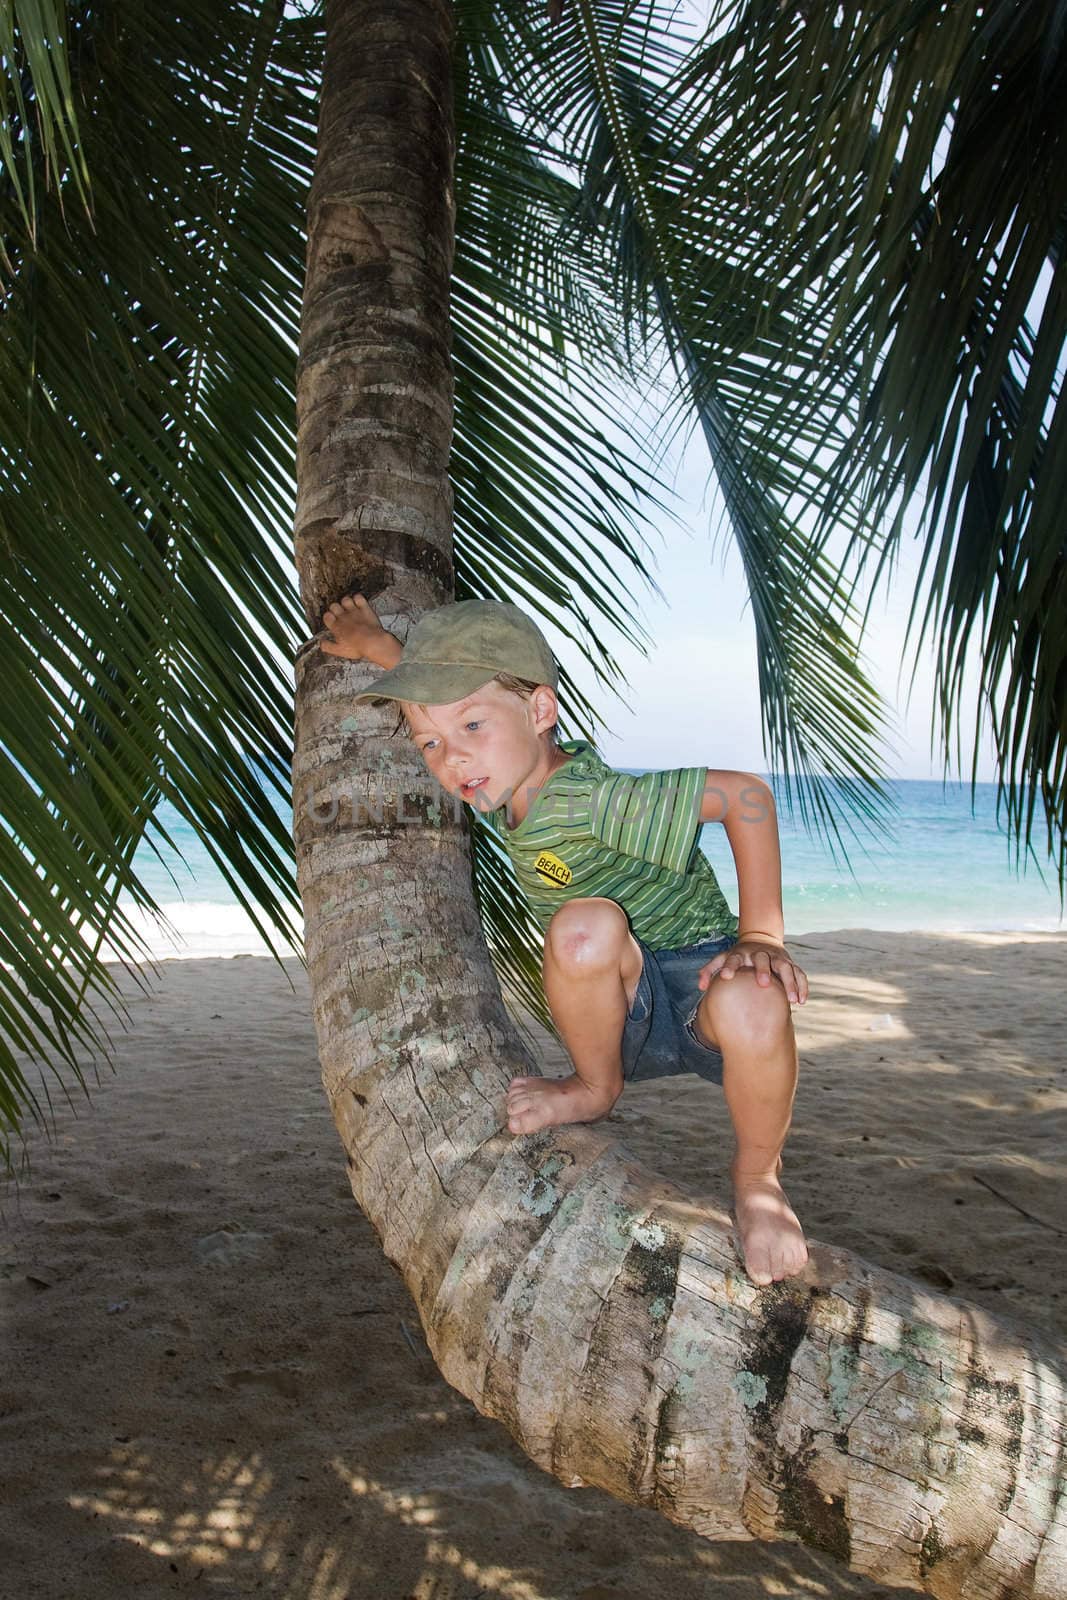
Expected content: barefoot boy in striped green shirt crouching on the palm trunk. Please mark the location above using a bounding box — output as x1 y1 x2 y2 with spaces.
322 595 808 1285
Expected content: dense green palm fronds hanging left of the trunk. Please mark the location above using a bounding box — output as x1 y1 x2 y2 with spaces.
0 3 322 1154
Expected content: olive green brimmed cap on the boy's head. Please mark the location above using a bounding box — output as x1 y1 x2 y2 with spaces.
355 600 558 706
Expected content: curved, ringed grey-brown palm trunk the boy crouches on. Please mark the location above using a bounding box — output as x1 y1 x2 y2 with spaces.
294 0 1067 1600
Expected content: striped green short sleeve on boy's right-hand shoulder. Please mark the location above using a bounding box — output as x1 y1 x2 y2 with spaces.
589 766 707 872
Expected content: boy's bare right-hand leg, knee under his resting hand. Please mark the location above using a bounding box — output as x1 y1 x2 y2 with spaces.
693 968 808 1283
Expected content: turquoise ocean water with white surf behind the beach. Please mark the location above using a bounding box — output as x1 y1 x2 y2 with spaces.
106 768 1064 960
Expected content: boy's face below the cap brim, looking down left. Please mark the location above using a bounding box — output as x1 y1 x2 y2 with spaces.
403 683 555 811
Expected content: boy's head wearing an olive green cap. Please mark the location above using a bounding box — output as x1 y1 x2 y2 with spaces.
358 600 558 803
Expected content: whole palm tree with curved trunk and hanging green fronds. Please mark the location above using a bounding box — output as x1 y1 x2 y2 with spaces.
0 0 1065 1597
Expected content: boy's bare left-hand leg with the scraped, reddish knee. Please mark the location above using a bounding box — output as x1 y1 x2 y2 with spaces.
507 898 643 1133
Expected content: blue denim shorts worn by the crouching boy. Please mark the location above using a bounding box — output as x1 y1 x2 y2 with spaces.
622 934 736 1083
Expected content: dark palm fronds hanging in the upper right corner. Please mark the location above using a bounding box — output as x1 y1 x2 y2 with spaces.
668 0 1067 891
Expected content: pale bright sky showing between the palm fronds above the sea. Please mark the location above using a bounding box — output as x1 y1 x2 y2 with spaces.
544 412 993 782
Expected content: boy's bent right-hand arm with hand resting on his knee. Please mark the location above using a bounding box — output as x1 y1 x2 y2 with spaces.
699 766 808 1005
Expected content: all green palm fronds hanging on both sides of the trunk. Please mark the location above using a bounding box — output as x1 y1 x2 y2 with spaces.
0 0 1067 1164
